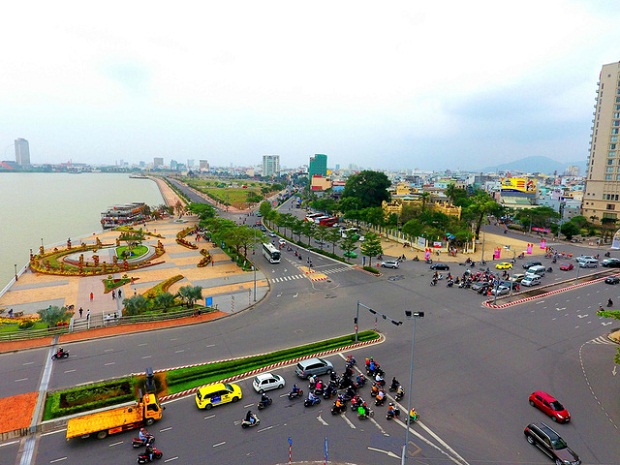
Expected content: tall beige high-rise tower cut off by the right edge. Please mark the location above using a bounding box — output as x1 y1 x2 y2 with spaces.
581 62 620 226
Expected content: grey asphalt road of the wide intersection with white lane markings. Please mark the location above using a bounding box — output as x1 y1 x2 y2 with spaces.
0 188 620 465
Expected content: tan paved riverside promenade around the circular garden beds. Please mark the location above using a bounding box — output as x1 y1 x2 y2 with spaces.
0 179 269 352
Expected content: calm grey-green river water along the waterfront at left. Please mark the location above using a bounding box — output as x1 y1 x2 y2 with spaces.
0 173 164 290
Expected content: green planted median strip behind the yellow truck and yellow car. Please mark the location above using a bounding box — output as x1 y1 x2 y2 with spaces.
43 331 381 421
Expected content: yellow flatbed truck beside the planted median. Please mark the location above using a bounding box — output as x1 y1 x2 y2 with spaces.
67 394 163 441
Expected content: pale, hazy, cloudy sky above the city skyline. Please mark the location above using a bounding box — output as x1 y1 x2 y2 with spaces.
0 0 620 170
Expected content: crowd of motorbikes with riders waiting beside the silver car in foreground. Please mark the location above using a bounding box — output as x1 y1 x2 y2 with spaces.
241 355 418 428
